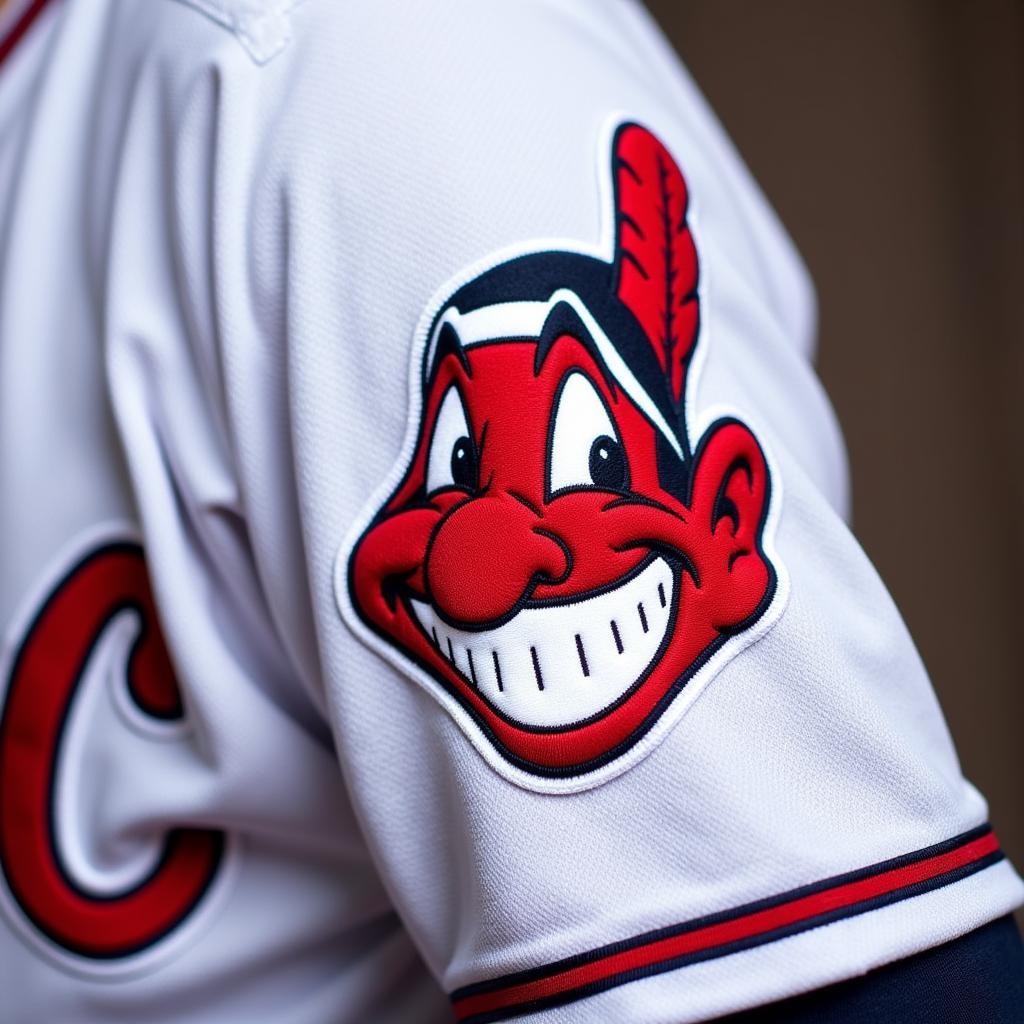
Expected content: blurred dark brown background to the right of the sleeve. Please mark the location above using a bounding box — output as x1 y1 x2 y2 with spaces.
648 0 1024 905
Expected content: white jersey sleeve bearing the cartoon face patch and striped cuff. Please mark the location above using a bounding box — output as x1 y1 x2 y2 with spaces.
99 0 1021 1024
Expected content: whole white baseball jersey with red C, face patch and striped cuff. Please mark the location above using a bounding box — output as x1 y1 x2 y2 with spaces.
0 0 1024 1024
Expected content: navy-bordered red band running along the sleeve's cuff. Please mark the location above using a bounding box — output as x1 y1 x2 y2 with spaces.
452 829 999 1021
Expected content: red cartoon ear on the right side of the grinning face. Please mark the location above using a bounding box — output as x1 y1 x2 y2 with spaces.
690 420 772 632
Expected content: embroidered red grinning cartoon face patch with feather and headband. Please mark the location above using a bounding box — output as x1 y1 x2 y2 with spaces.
338 124 780 788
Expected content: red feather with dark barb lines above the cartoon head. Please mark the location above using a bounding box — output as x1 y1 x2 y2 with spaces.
611 124 699 409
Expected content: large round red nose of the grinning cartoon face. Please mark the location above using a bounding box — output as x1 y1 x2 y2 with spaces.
426 494 569 623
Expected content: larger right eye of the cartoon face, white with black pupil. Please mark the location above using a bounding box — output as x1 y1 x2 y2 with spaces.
548 371 630 494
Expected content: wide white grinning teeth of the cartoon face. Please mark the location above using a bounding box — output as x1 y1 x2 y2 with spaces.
411 557 676 726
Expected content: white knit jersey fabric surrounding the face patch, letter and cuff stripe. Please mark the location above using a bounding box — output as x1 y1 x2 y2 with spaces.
0 0 1024 1024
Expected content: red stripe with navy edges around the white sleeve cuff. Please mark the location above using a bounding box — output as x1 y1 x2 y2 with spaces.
452 825 1004 1024
